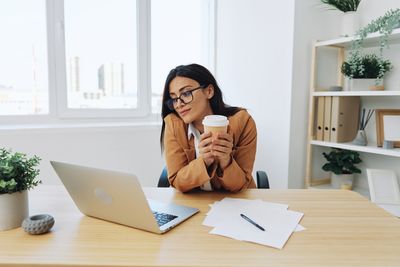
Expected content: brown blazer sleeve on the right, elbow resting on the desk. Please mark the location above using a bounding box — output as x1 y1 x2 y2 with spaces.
215 115 257 192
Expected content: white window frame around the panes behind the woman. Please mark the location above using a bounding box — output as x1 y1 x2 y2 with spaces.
0 0 216 125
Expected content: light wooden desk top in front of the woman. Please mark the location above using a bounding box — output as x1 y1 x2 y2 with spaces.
0 186 400 266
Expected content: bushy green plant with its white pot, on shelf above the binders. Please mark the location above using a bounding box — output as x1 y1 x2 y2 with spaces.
341 54 392 91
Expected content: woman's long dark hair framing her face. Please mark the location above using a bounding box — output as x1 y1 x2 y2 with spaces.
160 64 241 151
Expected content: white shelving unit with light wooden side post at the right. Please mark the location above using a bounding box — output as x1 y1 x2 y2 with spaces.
305 28 400 198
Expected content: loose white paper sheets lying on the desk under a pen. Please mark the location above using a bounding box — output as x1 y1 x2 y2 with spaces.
203 198 305 249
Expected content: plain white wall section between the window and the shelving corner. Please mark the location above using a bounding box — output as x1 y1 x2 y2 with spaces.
216 0 294 188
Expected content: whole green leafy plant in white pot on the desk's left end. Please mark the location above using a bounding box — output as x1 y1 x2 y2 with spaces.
0 148 41 230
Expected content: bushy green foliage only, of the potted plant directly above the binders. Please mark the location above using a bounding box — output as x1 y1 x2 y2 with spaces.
341 54 392 80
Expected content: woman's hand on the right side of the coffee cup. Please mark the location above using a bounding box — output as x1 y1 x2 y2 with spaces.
211 133 233 170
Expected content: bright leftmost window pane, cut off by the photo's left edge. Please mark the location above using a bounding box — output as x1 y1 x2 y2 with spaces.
0 0 49 116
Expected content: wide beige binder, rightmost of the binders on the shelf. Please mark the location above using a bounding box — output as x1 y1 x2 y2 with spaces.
330 96 361 143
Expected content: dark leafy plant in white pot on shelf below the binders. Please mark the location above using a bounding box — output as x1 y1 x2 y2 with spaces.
322 148 362 189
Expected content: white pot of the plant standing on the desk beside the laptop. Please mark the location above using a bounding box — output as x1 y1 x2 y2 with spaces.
0 190 29 231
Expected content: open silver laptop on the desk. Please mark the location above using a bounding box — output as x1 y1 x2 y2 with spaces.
50 161 199 234
